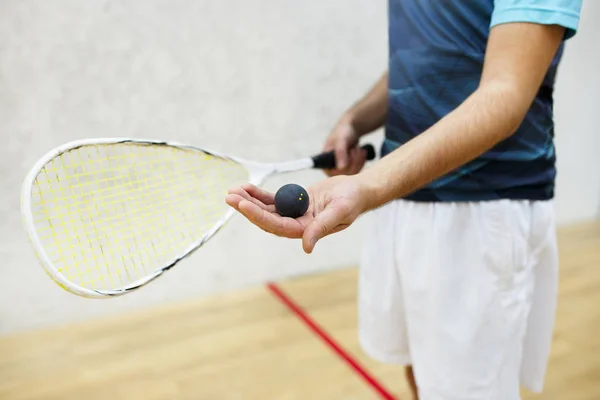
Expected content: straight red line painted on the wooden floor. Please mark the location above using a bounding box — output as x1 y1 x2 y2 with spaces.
267 283 399 400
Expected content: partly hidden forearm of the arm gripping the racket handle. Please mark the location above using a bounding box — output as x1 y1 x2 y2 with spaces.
342 71 388 135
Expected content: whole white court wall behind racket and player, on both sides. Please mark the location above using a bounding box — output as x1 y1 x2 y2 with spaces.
0 0 600 333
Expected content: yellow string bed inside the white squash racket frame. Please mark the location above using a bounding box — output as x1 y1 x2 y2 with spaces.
31 143 249 290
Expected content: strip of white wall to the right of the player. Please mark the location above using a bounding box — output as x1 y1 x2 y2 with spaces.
555 0 600 224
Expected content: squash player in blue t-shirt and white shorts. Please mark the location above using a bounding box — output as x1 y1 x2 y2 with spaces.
226 0 582 400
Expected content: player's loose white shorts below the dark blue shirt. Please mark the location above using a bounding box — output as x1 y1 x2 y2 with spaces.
358 200 558 400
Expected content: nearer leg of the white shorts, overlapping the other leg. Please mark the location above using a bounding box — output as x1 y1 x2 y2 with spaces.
395 201 534 400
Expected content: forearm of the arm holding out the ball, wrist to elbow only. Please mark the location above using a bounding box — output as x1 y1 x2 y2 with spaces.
359 85 532 209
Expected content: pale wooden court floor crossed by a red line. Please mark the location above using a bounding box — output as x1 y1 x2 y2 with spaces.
0 222 600 400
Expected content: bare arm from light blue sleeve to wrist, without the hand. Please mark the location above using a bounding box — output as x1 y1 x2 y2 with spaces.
359 23 564 209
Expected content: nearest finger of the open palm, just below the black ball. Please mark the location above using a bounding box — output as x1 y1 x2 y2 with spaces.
238 200 304 239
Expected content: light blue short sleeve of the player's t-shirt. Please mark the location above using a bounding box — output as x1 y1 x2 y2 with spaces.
490 0 580 40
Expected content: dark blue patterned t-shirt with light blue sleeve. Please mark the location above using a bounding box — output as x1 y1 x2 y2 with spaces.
382 0 582 201
